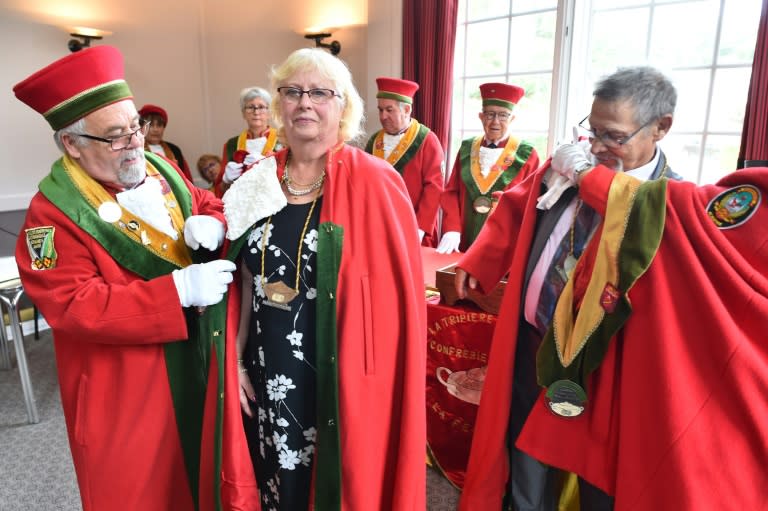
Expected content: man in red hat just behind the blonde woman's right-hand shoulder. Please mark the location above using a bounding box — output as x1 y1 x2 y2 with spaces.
365 77 445 247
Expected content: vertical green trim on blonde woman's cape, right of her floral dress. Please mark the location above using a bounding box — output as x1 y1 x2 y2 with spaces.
315 222 344 511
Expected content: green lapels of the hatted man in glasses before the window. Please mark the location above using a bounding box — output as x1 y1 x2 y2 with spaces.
459 139 533 247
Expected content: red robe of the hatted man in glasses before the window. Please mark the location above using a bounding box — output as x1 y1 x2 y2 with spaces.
440 139 539 252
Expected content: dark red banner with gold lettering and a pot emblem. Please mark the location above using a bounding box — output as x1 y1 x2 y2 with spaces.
427 299 496 488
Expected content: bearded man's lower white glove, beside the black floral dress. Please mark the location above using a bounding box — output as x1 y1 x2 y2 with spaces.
172 259 237 307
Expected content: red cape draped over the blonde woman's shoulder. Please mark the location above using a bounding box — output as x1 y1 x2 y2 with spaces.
222 144 426 511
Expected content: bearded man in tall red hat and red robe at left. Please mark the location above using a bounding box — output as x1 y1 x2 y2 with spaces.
14 46 256 511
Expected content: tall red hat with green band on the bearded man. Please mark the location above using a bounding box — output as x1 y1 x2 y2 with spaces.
13 46 133 130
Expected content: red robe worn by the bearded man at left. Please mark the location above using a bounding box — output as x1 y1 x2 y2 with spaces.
16 155 255 511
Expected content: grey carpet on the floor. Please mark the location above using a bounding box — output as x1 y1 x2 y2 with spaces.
0 330 458 511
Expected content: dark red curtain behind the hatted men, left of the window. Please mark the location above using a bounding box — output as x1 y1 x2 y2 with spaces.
403 0 459 154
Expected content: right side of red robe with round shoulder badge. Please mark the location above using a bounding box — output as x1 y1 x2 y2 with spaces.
517 167 768 511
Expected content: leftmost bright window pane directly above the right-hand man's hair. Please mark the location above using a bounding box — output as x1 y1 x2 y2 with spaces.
589 9 649 75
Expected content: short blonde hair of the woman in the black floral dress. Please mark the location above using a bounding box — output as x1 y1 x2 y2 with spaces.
270 48 363 142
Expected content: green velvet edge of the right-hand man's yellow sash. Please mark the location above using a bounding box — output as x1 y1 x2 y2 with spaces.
536 178 667 389
